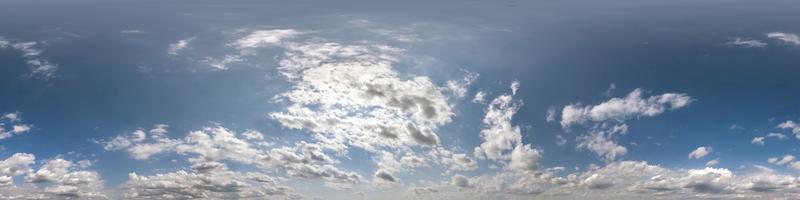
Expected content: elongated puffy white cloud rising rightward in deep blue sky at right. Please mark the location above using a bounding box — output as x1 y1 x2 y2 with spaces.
561 89 695 128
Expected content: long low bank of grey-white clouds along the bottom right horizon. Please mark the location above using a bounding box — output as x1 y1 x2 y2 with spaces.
450 161 800 199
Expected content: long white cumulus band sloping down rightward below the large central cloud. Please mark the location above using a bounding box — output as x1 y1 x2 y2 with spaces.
98 125 361 184
